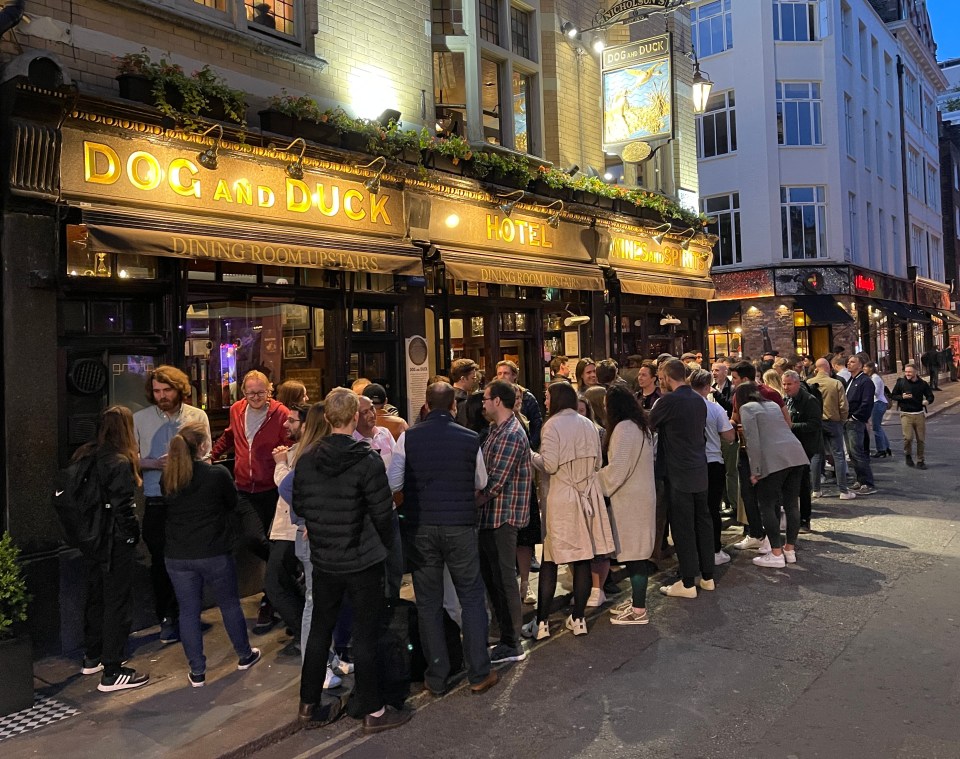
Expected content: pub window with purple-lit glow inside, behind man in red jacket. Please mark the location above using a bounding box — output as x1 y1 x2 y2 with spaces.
184 301 330 411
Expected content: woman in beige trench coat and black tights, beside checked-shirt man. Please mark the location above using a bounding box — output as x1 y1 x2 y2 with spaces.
524 382 615 640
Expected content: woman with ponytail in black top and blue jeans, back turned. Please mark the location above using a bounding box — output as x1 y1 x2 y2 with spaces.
160 422 260 688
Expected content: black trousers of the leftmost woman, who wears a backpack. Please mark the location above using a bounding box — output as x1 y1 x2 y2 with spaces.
83 542 136 674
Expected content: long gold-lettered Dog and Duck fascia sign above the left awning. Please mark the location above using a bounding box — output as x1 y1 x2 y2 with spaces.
61 128 404 237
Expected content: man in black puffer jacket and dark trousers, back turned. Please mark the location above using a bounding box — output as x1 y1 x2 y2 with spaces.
290 388 413 733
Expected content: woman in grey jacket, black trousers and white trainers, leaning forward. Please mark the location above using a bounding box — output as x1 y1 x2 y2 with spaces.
736 382 809 567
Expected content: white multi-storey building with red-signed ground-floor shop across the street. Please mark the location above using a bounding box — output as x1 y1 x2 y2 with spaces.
690 0 949 371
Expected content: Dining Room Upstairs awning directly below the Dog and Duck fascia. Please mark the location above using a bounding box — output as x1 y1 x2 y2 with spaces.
83 209 423 276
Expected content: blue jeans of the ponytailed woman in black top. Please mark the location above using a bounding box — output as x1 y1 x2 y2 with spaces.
164 554 251 675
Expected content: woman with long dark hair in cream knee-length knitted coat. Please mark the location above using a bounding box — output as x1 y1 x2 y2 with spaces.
600 387 657 625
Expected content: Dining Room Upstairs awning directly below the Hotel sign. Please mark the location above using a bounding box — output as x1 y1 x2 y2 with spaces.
440 248 604 292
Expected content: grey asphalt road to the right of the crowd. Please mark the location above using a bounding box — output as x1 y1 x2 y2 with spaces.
257 416 960 759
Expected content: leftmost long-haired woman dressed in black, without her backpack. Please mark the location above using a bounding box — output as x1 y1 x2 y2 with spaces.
73 406 150 693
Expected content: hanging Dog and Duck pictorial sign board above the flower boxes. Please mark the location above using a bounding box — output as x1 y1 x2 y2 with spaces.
601 34 673 155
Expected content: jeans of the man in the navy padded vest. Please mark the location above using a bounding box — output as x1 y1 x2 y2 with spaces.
404 525 490 692
